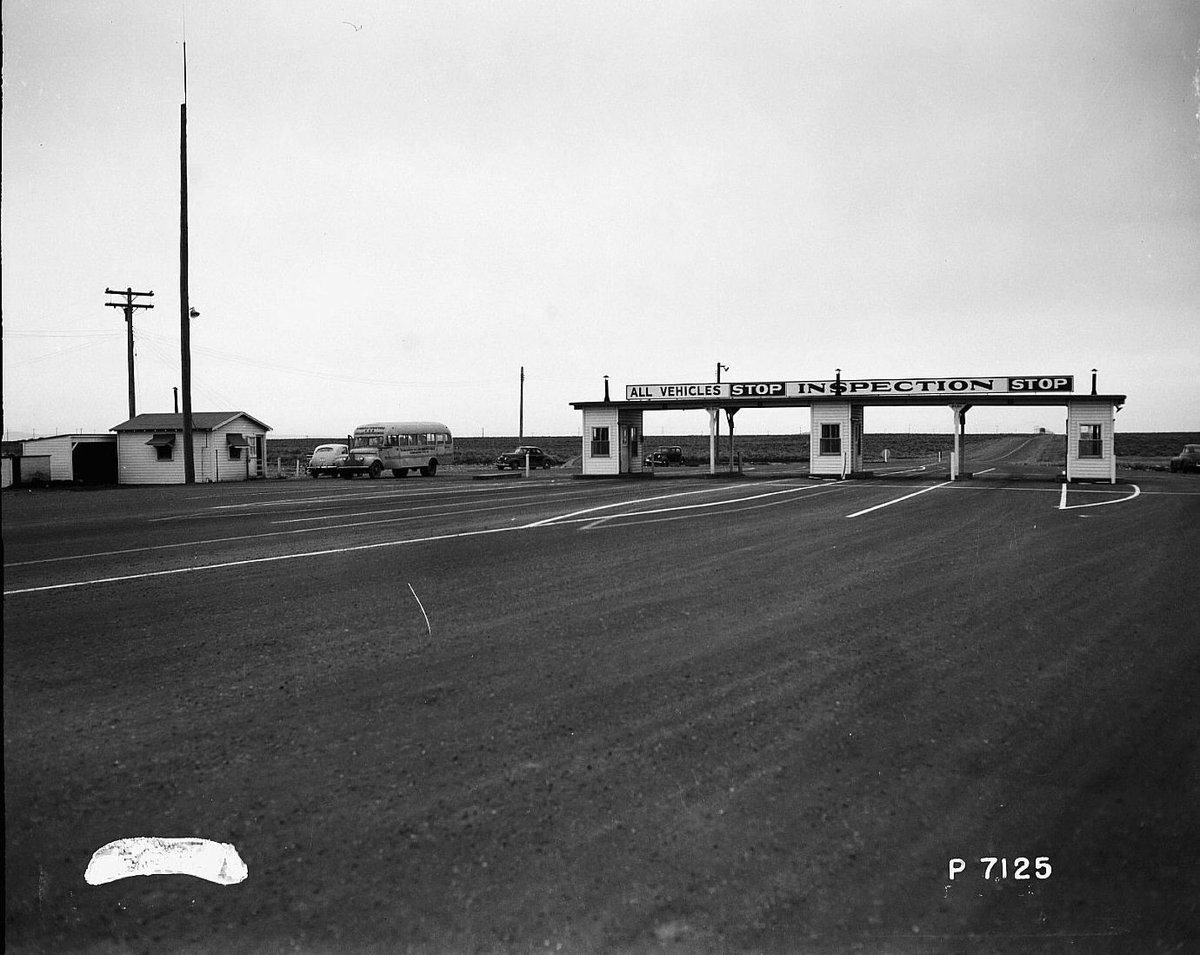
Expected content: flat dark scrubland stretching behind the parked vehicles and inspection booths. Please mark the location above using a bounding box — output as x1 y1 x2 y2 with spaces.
266 431 1200 475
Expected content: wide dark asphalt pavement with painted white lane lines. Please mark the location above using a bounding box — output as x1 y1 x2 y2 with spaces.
4 442 1200 953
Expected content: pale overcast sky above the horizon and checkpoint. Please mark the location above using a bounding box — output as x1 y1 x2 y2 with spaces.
0 0 1200 437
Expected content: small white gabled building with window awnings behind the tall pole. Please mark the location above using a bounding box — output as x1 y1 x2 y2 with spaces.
113 412 271 485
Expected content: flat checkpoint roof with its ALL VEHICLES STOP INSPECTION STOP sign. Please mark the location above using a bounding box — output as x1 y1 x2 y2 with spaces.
571 374 1126 410
